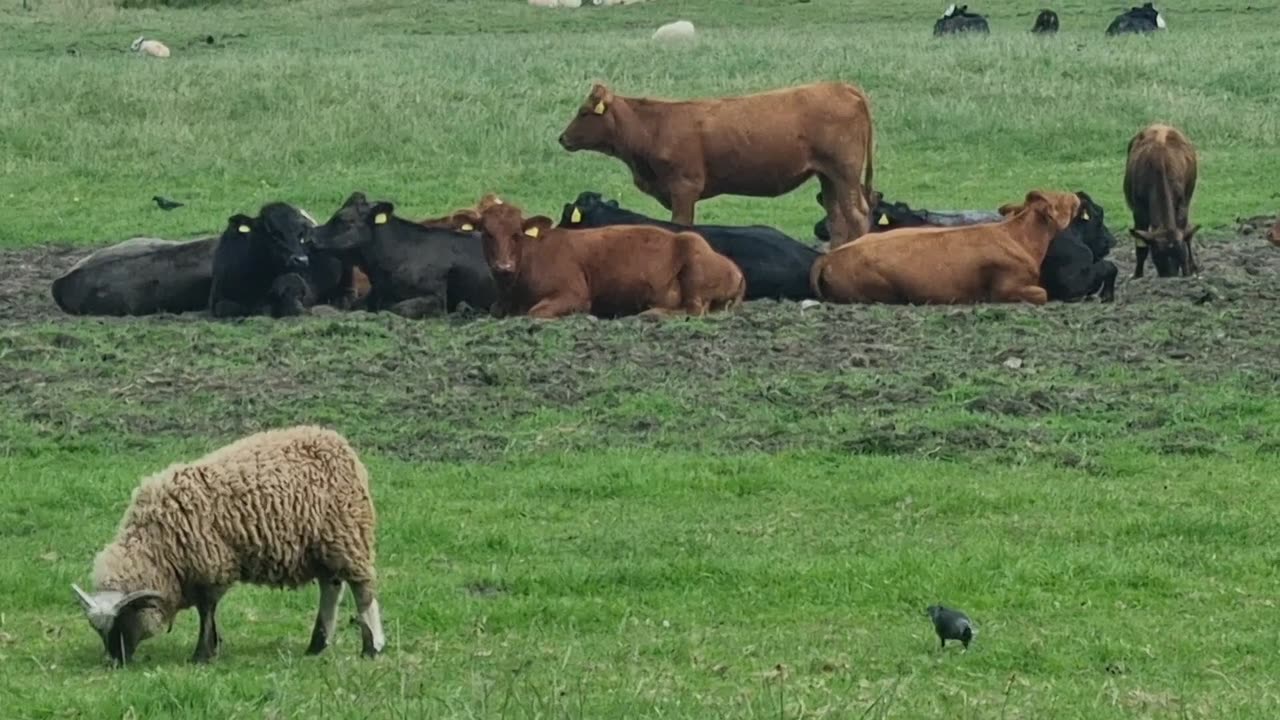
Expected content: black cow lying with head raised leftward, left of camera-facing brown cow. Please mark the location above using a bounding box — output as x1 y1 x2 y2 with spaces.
315 192 498 318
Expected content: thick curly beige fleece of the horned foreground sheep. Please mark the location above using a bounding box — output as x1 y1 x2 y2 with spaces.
93 427 376 594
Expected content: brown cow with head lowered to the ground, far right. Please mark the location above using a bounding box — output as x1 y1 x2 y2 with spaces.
1124 123 1199 278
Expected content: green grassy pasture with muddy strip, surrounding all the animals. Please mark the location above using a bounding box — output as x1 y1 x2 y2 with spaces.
0 0 1280 720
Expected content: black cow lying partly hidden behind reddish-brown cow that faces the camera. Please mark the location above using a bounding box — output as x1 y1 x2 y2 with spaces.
559 192 819 300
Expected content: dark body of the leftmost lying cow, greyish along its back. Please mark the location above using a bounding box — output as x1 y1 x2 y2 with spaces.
51 236 218 315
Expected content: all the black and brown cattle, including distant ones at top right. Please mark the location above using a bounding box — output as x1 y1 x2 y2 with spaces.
52 3 1239 318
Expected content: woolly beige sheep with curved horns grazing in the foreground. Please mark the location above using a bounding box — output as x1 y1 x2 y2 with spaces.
72 427 387 664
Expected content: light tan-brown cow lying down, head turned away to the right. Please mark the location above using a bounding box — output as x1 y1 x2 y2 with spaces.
809 191 1080 305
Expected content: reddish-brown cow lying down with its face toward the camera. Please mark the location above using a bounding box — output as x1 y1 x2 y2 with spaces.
479 204 746 318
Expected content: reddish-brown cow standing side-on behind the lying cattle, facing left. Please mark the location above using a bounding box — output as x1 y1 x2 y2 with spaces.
559 82 872 249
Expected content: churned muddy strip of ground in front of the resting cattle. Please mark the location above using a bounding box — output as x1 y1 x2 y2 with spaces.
0 228 1280 471
